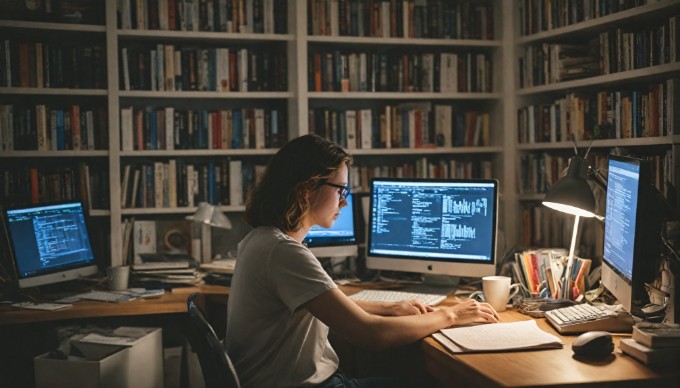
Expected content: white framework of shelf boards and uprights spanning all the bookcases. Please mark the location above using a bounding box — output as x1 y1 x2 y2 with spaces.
0 0 680 265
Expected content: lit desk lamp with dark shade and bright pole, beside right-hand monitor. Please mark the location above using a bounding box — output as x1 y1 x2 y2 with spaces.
543 156 596 299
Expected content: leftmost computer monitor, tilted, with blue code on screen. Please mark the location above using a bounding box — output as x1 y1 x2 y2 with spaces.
3 201 98 288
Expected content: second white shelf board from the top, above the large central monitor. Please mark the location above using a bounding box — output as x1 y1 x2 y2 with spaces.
308 92 502 100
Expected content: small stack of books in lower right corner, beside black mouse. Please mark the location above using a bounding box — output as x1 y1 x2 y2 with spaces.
619 322 680 366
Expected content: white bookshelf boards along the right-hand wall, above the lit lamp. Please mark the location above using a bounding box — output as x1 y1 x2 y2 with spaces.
507 0 680 256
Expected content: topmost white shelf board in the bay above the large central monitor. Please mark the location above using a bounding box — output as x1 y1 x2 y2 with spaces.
307 35 502 48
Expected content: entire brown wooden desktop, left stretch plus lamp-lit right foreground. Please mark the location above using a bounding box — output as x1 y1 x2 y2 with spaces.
0 286 680 386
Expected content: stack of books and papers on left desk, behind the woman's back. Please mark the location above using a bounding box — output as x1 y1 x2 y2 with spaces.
131 253 204 288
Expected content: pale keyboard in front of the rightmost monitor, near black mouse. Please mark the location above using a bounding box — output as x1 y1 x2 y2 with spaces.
545 303 634 334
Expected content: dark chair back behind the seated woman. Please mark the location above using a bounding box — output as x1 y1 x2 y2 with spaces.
184 293 241 388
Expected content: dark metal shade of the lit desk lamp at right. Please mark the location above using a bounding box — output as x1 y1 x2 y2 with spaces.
543 156 596 217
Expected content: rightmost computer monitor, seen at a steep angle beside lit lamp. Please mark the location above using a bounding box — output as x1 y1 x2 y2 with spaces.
601 155 663 312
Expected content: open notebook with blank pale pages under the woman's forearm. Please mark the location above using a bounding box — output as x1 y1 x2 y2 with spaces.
432 320 563 353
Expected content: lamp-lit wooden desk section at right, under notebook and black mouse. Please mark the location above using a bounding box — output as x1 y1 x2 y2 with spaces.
421 298 680 387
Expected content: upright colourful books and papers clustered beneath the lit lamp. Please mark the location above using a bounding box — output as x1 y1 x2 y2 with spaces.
512 248 591 300
